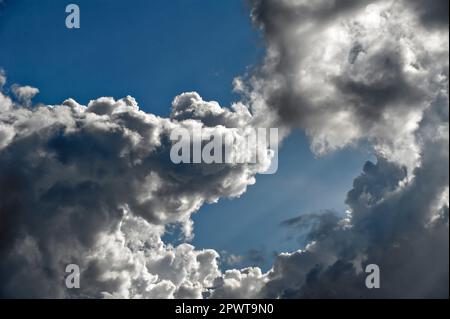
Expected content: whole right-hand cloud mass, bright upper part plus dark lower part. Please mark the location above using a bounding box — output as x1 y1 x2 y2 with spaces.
207 0 449 298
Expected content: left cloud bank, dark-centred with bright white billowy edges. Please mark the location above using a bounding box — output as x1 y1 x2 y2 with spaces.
0 77 270 298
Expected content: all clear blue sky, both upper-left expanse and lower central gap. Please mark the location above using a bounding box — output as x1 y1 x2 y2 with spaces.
0 0 371 268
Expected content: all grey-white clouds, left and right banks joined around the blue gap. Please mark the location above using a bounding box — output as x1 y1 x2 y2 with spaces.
0 0 449 298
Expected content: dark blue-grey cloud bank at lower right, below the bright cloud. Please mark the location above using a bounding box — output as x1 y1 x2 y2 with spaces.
212 80 449 298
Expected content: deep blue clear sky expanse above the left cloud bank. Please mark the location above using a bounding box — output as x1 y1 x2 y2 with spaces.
0 0 263 111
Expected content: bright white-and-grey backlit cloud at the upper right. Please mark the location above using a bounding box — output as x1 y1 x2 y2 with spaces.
239 0 448 169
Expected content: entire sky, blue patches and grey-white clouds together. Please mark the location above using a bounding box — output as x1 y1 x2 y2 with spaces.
0 0 448 298
